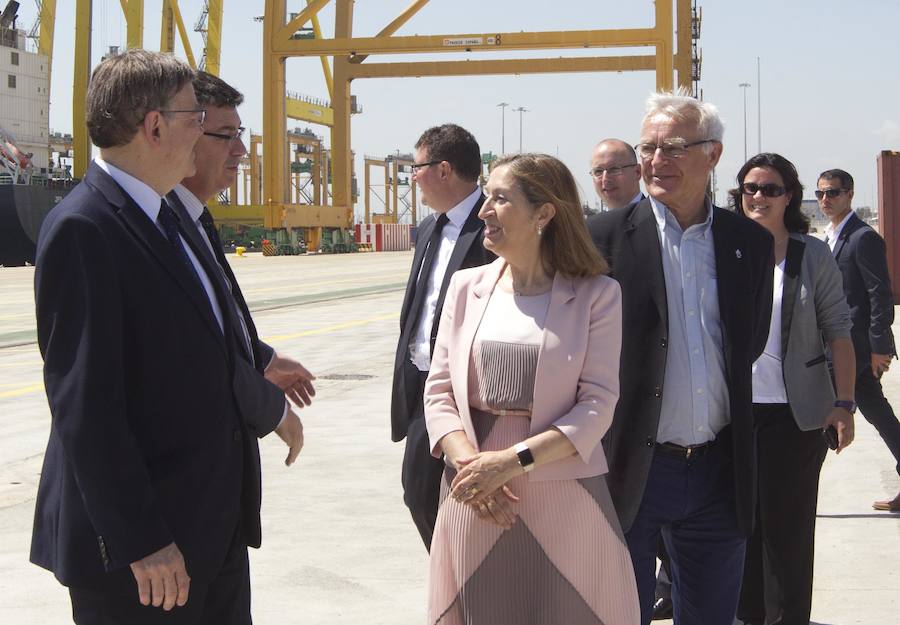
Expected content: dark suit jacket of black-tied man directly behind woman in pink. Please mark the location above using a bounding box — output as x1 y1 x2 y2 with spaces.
391 194 496 442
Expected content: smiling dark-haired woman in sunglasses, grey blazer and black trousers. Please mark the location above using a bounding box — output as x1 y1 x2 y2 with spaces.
730 153 855 625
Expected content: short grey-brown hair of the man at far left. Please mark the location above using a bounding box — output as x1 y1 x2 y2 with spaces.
85 49 194 148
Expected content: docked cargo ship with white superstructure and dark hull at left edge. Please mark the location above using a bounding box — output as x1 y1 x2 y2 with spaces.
0 1 74 267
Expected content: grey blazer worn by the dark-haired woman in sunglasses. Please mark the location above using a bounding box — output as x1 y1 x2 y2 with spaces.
781 233 851 431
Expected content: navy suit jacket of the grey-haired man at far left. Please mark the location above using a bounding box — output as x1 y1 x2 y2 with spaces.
31 164 270 592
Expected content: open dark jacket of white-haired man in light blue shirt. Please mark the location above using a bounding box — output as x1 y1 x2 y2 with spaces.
589 199 774 533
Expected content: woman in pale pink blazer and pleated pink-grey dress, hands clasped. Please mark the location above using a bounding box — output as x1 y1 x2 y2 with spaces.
425 154 640 625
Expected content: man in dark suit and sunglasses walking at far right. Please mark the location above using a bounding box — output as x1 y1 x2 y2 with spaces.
815 169 900 512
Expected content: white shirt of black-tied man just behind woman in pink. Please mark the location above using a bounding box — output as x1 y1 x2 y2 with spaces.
409 186 481 371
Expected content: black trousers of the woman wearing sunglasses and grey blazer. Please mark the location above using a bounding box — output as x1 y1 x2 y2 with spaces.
738 404 827 625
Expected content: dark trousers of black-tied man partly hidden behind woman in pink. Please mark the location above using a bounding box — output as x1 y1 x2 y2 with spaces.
400 361 444 551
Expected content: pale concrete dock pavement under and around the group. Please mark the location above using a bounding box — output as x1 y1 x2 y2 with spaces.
0 253 900 625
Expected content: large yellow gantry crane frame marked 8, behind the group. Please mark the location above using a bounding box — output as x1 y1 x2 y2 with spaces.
263 0 699 227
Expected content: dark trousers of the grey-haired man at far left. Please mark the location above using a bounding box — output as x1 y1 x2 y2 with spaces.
69 532 253 625
